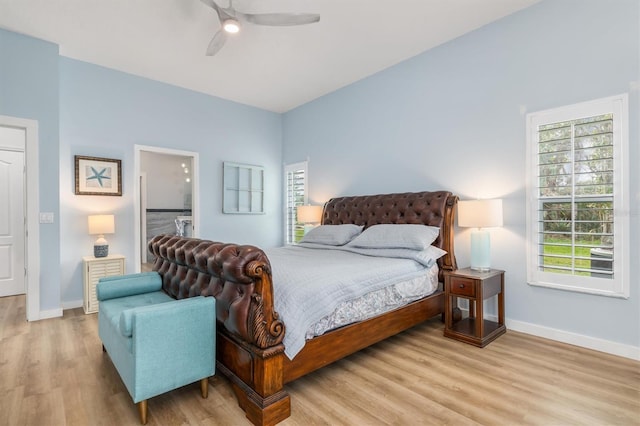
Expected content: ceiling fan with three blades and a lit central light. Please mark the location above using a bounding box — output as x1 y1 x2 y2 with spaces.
201 0 320 56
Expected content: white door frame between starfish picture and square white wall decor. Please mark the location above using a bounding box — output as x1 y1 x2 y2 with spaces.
133 144 200 272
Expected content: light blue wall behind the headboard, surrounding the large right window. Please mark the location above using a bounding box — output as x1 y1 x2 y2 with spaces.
283 0 640 347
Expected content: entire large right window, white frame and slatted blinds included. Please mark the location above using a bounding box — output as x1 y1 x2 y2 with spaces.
527 94 629 298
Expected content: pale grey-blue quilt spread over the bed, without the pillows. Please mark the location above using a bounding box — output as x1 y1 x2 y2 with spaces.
265 246 437 359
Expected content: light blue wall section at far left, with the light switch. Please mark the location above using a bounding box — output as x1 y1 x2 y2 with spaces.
0 30 60 311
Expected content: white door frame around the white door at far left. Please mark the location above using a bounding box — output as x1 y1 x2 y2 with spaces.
0 115 40 321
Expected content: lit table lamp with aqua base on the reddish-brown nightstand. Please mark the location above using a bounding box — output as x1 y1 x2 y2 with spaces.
458 199 502 271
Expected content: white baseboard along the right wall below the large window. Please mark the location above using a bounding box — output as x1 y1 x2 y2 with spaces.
461 309 640 361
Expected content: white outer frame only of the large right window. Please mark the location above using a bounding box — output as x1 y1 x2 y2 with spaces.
527 93 630 299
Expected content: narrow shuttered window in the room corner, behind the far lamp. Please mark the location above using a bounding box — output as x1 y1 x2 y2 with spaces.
284 161 308 244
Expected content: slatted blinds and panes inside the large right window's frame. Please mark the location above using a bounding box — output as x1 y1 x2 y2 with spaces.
538 114 614 279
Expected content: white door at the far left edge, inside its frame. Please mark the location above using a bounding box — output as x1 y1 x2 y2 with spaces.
0 150 25 297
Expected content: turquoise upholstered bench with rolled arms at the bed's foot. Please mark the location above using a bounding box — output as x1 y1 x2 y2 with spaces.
97 272 216 424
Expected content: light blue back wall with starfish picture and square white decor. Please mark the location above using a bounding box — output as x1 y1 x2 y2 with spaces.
60 57 282 303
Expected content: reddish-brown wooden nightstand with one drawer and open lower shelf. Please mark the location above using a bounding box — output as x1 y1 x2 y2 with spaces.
444 268 507 348
